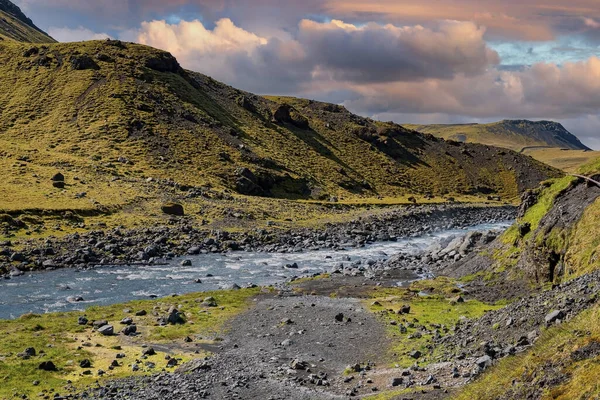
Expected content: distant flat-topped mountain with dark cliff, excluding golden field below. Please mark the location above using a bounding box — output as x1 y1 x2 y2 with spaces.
404 120 590 151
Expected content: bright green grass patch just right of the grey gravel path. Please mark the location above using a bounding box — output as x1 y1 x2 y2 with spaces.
365 281 502 368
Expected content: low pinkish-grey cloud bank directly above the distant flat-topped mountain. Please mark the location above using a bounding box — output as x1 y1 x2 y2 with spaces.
347 57 600 119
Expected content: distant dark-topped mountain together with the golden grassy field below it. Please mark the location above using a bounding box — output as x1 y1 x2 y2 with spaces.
404 121 600 172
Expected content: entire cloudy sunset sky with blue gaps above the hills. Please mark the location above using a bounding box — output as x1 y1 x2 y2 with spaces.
15 0 600 149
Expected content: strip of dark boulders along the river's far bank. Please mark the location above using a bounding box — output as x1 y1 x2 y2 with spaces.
0 205 516 278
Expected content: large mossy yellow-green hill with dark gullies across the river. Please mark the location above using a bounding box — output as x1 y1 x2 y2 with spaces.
0 41 556 238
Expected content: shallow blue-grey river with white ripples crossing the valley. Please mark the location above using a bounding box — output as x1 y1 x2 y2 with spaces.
0 222 510 319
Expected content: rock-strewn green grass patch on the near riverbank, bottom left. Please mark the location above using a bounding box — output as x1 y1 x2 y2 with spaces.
0 289 261 399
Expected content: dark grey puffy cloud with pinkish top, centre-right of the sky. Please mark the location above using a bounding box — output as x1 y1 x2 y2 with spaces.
298 20 500 82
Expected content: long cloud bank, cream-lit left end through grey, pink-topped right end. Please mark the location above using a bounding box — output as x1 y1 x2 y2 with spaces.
128 18 499 93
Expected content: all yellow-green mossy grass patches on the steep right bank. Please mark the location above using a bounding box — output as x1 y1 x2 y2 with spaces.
456 160 600 400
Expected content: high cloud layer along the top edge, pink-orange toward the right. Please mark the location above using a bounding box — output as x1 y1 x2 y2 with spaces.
15 0 600 41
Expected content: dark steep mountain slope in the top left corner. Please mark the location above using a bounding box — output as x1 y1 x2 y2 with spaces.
0 0 56 43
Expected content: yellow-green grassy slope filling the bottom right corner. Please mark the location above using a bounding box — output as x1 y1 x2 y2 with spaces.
454 305 600 400
